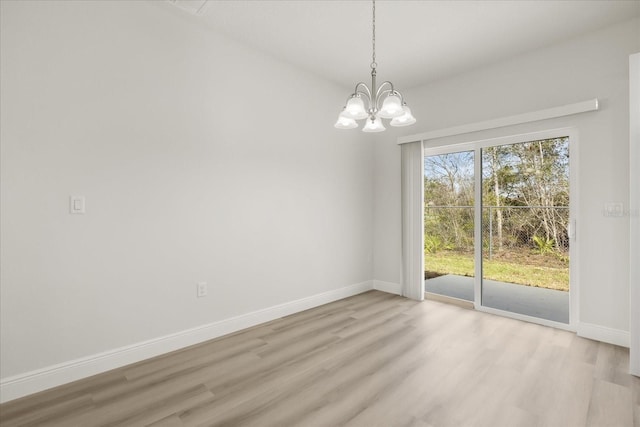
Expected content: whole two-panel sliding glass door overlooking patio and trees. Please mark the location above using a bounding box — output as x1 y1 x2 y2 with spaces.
424 135 571 324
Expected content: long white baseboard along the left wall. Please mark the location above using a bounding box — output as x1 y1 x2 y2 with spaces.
0 280 373 403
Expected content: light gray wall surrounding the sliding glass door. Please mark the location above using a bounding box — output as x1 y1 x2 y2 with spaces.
374 16 640 340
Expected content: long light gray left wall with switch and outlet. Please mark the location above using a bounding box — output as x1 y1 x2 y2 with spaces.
0 1 373 379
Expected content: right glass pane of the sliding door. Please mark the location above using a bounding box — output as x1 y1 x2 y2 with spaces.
481 137 569 323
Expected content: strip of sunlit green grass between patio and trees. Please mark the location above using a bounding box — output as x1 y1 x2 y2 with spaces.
424 251 569 291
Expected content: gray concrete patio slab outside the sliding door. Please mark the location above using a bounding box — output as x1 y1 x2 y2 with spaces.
425 274 569 323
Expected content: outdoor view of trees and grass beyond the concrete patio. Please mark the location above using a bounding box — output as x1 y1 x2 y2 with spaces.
424 137 569 290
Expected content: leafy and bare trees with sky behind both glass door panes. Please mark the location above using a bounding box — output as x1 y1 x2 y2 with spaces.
424 137 569 260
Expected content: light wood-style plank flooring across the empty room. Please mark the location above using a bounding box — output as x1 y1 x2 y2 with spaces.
0 291 640 427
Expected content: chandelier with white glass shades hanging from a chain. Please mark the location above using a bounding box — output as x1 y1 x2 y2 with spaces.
334 0 416 132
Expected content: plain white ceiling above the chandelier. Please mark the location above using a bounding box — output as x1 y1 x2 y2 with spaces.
168 0 640 89
